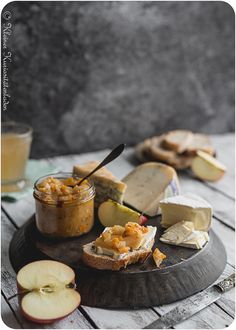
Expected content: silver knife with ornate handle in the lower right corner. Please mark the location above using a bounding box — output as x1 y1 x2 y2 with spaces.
144 273 235 329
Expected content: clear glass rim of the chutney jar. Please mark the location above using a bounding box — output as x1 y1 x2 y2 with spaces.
34 171 94 201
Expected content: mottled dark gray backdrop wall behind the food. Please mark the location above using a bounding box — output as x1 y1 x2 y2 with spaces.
3 1 234 157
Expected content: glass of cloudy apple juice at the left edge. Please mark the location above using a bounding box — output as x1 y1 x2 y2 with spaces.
1 122 32 192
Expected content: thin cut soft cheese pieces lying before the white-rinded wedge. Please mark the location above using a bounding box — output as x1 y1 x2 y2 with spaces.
160 221 209 249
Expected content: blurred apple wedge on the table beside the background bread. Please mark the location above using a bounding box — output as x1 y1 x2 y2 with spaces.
191 150 226 181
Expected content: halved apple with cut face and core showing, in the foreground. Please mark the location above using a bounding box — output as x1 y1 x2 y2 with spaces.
17 260 81 323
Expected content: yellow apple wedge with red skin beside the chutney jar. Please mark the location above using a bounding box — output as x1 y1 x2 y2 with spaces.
98 199 147 227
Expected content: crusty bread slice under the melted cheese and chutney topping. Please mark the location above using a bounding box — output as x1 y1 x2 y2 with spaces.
82 239 154 270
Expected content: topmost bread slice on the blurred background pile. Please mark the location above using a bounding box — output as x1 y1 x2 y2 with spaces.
162 130 194 154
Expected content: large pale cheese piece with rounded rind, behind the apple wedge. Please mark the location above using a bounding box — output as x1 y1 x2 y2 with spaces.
122 162 179 216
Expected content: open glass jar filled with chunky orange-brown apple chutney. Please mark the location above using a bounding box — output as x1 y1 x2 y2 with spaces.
34 173 95 238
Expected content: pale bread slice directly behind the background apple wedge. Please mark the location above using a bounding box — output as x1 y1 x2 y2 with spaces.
185 134 215 156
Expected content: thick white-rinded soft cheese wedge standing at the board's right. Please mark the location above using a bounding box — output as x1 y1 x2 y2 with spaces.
160 194 212 231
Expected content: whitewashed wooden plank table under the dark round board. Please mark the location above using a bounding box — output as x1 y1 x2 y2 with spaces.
2 134 235 329
